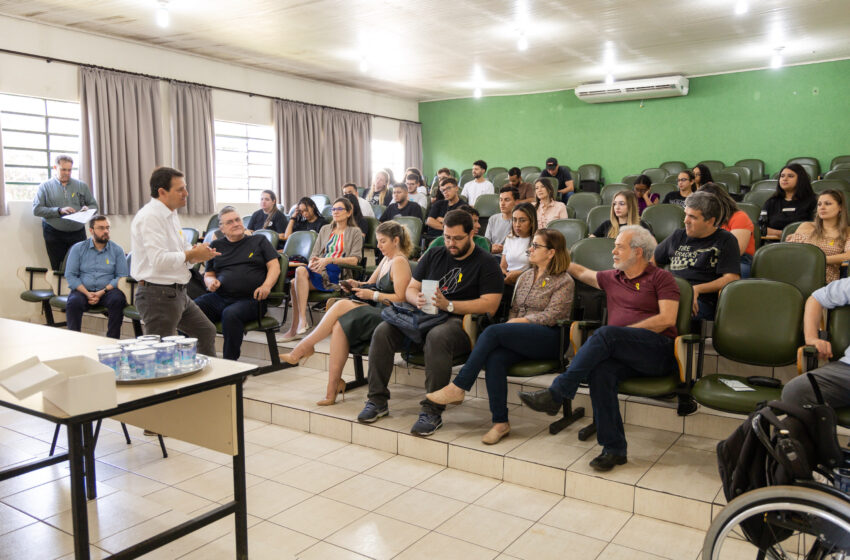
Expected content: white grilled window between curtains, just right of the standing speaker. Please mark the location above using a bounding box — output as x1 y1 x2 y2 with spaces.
214 121 275 203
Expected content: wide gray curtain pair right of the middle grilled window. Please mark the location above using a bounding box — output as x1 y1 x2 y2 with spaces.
274 99 372 207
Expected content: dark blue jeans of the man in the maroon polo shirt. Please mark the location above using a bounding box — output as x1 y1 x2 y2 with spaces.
549 326 675 455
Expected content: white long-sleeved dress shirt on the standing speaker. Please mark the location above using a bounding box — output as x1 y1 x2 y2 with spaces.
130 198 192 284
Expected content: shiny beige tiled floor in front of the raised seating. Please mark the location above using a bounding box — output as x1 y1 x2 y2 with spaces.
0 410 706 560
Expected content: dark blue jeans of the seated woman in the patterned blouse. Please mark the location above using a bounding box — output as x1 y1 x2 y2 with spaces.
453 323 560 423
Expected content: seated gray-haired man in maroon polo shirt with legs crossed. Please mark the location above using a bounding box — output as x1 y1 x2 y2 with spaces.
519 226 679 471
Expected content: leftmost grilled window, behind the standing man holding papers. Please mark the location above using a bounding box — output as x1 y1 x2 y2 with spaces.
0 94 80 201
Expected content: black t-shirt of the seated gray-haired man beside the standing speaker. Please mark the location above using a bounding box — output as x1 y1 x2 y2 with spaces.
207 235 277 298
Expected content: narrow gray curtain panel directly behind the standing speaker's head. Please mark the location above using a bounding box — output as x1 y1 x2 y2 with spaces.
168 82 215 214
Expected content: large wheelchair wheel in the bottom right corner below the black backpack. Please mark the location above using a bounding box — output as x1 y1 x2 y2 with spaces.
702 486 850 560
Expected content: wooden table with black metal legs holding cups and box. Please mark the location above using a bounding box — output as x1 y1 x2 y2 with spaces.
0 319 256 560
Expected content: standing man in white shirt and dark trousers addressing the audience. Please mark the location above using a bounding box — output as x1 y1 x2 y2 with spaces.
130 167 220 357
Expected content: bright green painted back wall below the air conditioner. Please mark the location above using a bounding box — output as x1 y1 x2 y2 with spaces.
419 60 850 182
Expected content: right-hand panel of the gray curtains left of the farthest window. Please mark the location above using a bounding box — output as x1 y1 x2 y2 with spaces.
317 109 372 196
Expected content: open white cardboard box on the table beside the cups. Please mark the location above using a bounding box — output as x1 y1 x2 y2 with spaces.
43 356 118 415
